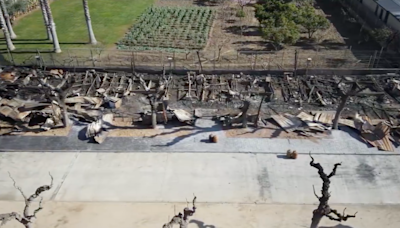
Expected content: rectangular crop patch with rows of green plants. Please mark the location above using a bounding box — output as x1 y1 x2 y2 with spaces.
117 7 214 49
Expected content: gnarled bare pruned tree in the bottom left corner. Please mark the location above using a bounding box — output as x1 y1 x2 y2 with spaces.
0 173 53 228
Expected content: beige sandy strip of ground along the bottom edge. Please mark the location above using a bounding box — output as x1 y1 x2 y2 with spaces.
0 202 400 228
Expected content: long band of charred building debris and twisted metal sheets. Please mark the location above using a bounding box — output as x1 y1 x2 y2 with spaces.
0 68 400 151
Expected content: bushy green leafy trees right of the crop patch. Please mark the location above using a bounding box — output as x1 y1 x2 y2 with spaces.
255 0 330 48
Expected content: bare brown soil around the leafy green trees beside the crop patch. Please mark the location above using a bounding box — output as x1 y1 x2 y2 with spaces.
139 0 380 69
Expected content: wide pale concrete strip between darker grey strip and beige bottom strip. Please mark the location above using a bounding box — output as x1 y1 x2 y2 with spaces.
0 152 400 205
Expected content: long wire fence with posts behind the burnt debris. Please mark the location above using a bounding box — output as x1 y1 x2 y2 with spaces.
0 49 400 70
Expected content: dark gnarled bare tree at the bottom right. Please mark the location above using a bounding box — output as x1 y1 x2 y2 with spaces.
310 153 357 228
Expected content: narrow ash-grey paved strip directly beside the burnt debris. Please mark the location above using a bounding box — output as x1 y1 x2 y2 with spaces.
0 127 400 155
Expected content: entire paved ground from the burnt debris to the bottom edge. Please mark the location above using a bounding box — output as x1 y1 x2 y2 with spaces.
0 121 400 228
